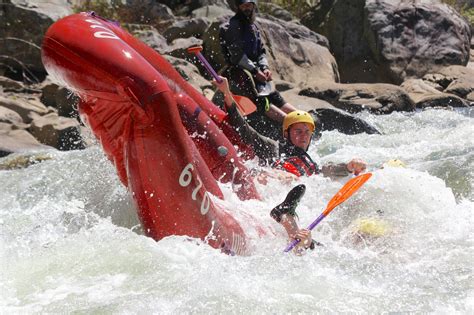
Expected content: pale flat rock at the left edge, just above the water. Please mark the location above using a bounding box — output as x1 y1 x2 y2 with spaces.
0 123 52 157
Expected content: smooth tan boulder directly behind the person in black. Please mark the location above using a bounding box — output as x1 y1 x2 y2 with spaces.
203 16 339 85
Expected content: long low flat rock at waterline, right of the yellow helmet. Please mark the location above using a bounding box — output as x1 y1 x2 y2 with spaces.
300 82 415 114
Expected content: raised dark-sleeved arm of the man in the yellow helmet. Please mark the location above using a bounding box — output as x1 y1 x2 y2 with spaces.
213 77 279 160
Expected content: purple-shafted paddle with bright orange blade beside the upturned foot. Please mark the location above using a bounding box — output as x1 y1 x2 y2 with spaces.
285 173 372 253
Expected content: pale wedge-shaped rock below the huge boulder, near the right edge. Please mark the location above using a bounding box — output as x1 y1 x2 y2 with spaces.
401 79 468 108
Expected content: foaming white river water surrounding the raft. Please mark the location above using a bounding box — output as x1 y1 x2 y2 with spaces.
0 110 474 314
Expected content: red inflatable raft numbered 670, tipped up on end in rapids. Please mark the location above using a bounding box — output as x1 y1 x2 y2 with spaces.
42 13 259 254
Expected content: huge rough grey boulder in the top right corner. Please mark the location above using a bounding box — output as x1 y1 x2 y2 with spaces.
303 0 471 84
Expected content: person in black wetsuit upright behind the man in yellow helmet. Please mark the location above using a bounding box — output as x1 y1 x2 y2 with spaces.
219 0 295 139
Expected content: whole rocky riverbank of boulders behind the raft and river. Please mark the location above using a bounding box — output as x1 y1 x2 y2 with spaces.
0 0 474 156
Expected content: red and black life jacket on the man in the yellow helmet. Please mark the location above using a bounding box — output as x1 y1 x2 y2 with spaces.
272 150 319 177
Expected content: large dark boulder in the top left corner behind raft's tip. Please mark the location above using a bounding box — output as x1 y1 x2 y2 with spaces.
0 0 72 82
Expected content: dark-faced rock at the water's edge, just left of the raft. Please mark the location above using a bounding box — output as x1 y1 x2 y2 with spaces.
29 112 84 150
